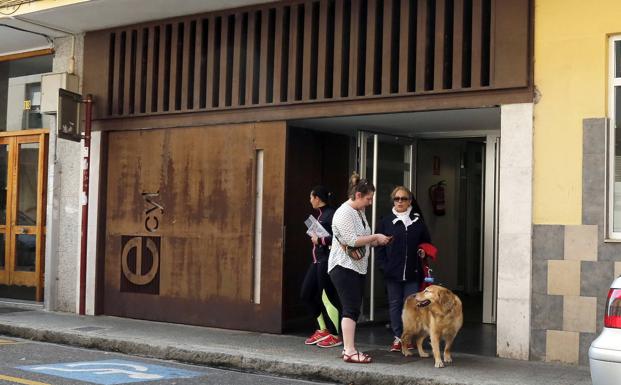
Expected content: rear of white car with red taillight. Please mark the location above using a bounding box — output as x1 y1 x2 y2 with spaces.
589 276 621 385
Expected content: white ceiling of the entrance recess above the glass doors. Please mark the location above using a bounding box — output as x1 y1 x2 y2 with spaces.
289 107 500 137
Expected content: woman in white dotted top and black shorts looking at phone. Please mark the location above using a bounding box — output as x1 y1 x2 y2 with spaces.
328 172 391 364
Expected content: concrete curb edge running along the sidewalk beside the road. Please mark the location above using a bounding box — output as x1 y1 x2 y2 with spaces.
0 324 456 385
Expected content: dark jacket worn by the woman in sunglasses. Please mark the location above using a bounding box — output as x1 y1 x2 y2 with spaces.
375 210 431 282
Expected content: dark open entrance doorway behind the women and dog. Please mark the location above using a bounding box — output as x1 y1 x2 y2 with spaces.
284 108 500 356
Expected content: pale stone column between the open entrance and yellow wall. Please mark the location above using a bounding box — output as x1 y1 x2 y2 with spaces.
496 103 533 360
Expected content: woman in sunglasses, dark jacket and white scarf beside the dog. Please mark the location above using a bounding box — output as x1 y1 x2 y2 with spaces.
375 186 431 352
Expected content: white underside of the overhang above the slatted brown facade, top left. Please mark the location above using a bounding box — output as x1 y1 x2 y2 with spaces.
0 0 274 56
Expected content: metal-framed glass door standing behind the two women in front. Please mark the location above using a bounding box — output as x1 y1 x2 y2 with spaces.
358 131 415 321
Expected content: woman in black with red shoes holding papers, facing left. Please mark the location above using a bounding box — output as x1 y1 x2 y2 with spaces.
300 186 343 348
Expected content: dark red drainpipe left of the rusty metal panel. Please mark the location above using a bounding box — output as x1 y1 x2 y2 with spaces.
79 94 93 315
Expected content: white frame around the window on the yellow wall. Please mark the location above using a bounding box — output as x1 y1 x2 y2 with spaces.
606 34 621 241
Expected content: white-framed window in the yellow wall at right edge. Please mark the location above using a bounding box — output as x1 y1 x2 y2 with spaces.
608 35 621 239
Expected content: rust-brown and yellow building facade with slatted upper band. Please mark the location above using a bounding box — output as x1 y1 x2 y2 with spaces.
14 0 621 364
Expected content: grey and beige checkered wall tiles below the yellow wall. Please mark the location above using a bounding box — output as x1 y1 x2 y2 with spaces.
530 119 621 365
